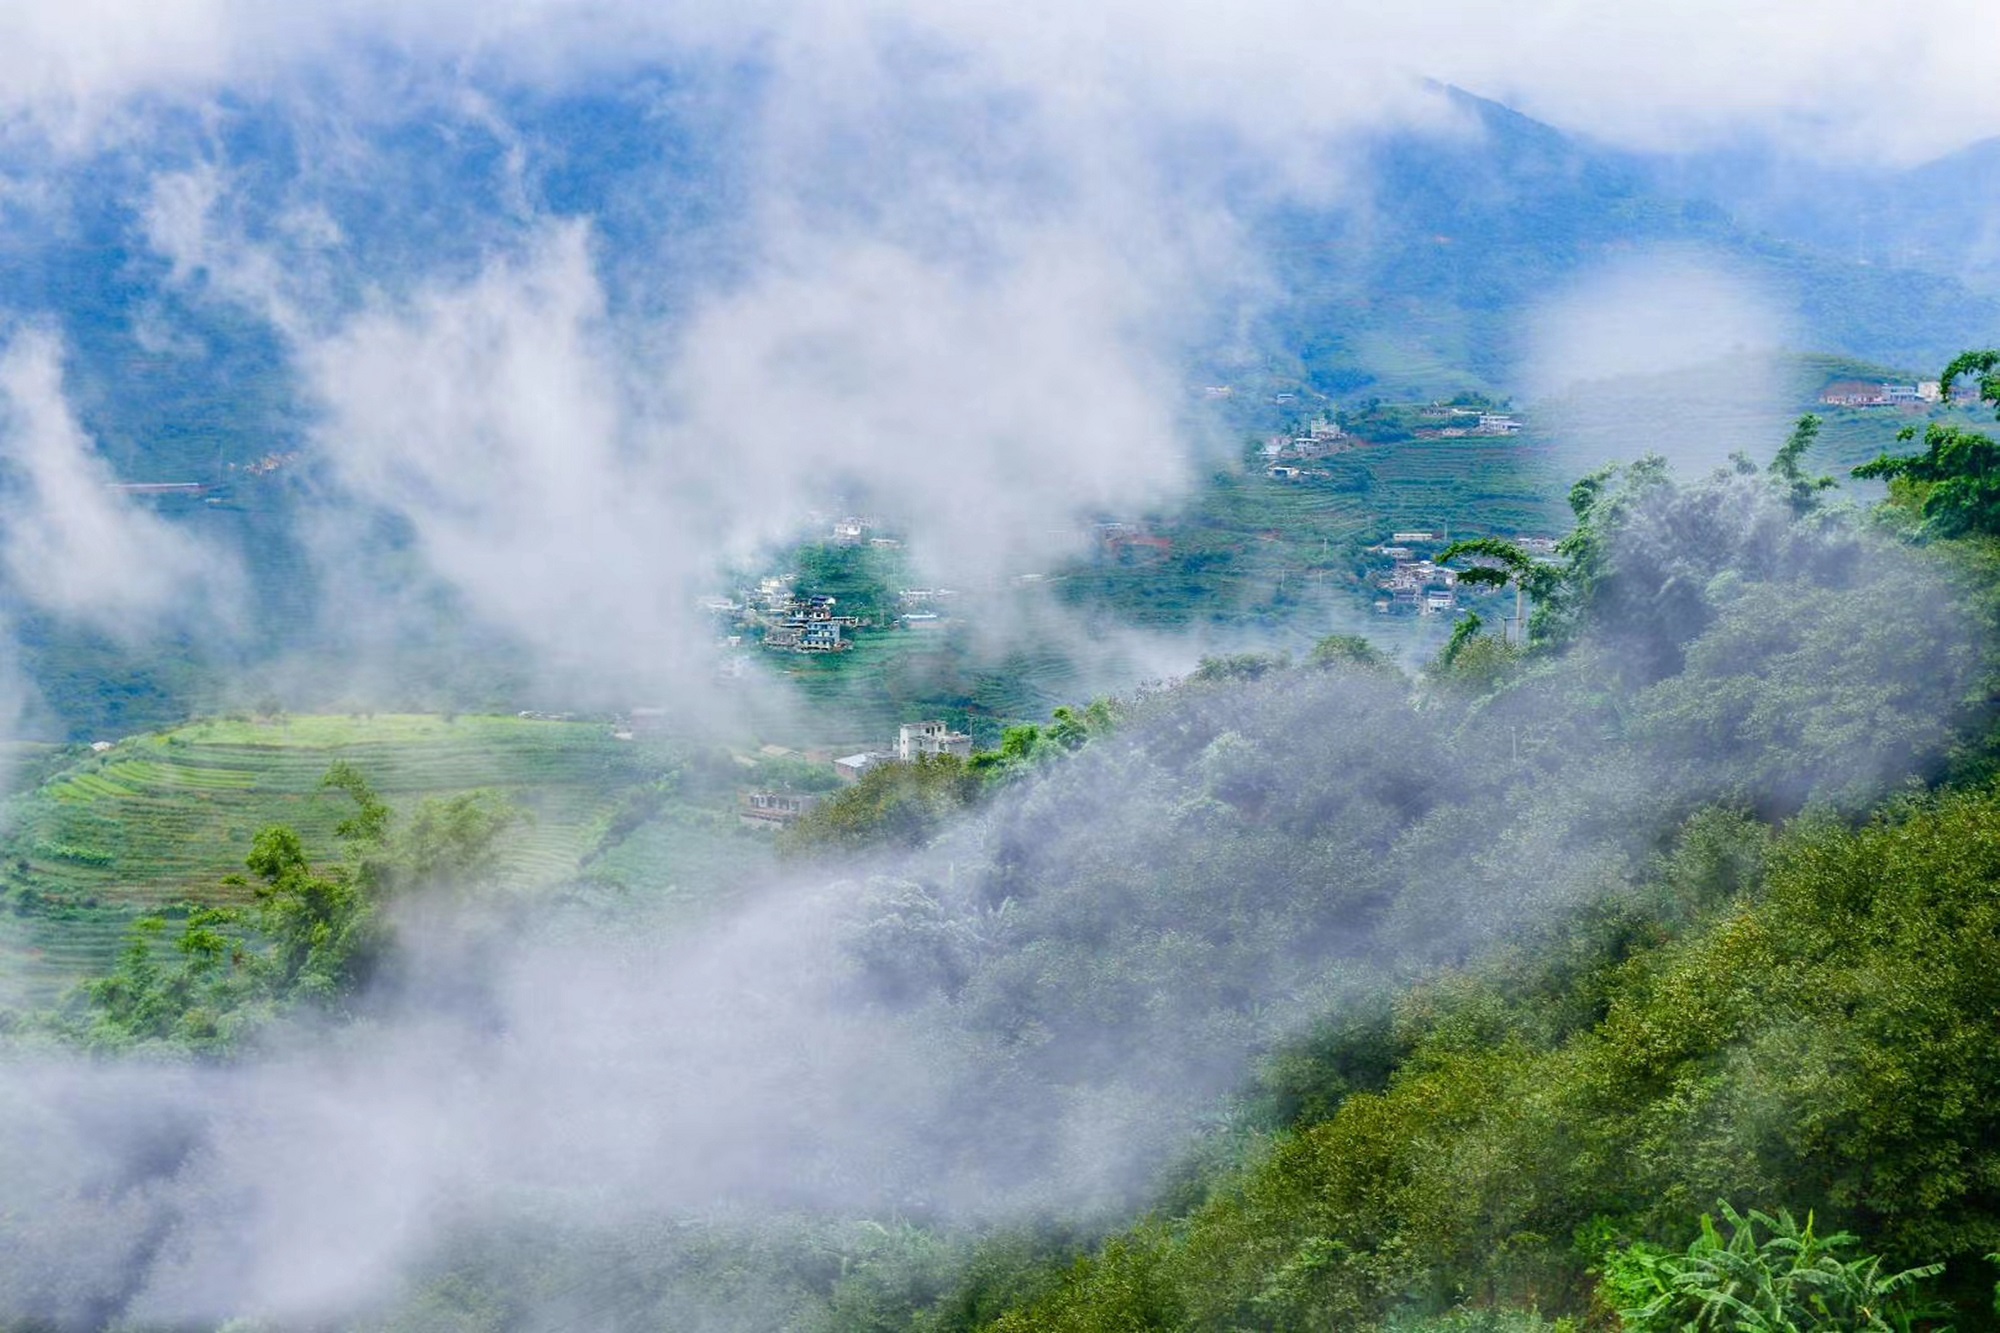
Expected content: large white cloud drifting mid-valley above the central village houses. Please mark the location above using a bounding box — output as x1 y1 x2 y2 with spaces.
300 197 1186 677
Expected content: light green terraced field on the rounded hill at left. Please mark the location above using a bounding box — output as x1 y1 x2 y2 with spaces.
0 715 768 1003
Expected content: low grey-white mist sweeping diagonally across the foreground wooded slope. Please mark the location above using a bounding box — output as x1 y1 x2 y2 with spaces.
0 454 1984 1327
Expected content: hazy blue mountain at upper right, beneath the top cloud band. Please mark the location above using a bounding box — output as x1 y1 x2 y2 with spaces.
1232 88 2000 396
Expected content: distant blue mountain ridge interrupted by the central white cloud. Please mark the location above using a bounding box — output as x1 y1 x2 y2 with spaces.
0 70 2000 480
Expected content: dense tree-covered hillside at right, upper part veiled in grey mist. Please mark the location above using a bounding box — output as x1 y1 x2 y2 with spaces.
768 424 2000 1329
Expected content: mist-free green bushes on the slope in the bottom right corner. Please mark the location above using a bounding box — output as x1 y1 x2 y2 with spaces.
964 793 2000 1329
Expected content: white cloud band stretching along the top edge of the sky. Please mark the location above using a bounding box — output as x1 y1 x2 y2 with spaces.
0 0 2000 158
